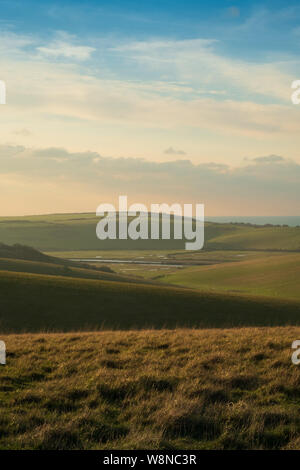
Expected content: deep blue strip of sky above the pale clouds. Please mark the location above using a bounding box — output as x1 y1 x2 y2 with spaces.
0 0 300 57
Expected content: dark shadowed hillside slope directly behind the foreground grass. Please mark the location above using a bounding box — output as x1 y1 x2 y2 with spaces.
0 271 300 332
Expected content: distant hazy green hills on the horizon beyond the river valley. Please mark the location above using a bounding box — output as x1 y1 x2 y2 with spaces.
0 214 300 252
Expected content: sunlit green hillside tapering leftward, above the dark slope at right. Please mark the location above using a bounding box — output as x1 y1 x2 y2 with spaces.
160 253 300 301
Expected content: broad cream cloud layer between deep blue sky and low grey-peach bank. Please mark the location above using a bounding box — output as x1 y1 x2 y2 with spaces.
0 27 300 179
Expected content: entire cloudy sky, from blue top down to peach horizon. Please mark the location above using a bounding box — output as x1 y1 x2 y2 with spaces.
0 0 300 216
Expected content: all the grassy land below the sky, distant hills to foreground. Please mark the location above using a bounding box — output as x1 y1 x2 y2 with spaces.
0 218 300 450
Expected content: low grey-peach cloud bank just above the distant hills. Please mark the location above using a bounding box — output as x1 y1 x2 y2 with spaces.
0 146 300 215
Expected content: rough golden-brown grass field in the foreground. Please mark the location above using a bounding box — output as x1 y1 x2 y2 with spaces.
0 327 300 449
